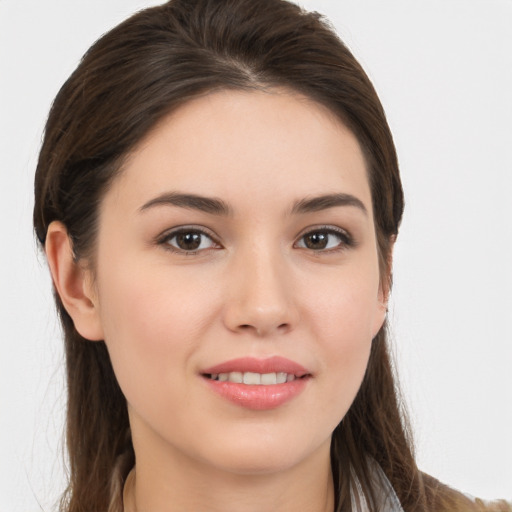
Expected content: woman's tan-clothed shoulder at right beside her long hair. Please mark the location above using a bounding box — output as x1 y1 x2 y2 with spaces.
423 474 512 512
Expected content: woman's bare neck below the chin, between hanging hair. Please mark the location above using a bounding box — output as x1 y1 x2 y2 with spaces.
124 436 334 512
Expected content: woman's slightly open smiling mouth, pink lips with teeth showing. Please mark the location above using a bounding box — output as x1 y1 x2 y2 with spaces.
201 356 311 411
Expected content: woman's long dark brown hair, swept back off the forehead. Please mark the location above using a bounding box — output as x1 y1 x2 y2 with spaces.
34 0 427 512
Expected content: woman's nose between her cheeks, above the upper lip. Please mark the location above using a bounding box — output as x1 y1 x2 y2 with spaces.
224 248 299 337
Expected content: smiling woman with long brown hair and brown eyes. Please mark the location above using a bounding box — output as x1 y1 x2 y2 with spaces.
34 0 505 511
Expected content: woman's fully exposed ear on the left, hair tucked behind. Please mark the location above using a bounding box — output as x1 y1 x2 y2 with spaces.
45 221 103 341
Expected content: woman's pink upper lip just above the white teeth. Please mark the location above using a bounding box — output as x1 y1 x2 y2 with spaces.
201 356 310 377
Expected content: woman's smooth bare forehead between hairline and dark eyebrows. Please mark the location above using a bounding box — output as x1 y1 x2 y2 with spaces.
108 90 371 211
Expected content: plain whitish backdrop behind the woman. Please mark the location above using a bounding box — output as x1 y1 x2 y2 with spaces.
0 0 512 512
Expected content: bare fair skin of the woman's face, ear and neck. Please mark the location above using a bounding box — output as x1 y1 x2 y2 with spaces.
47 90 386 512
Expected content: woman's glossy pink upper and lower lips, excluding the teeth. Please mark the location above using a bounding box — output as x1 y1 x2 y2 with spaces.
201 356 311 411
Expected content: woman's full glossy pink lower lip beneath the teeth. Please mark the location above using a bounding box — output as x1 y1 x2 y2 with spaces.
203 377 309 411
